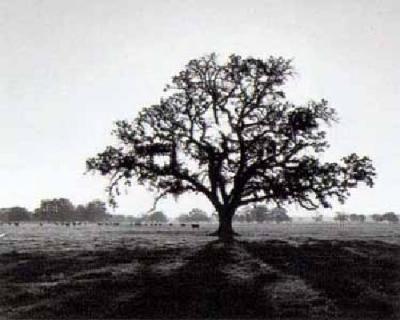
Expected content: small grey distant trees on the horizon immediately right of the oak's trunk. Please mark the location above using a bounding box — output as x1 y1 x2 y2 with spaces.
234 205 292 223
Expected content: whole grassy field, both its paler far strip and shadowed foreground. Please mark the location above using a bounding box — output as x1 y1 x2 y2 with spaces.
0 223 400 319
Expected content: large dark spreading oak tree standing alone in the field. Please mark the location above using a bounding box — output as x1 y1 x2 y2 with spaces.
87 54 375 240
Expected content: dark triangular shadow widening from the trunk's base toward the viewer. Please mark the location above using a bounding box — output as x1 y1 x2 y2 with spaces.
113 241 282 318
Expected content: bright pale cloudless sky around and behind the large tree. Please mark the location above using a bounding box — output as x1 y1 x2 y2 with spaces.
0 0 400 216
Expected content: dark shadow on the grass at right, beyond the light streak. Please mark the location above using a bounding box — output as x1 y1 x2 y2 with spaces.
245 239 400 319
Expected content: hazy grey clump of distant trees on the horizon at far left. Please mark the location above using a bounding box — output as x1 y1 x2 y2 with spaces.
0 198 111 222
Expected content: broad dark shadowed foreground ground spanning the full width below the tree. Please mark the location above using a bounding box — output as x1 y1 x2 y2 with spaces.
0 239 400 319
